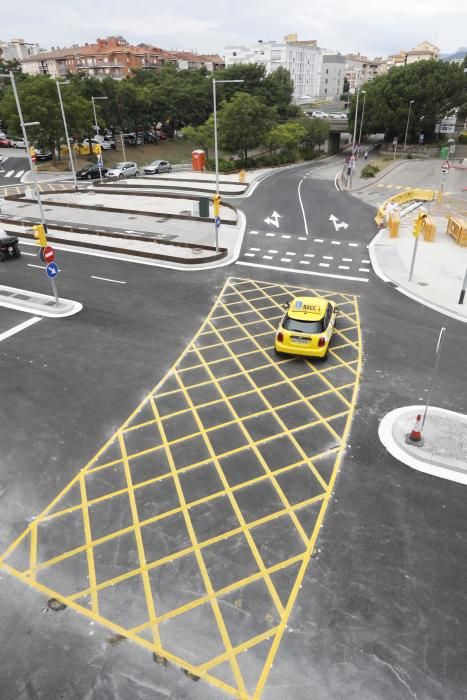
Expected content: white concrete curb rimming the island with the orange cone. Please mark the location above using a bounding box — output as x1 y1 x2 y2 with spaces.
378 406 467 485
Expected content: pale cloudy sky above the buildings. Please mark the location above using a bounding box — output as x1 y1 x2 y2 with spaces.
0 0 467 58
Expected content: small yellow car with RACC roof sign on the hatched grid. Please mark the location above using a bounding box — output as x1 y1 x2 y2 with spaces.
275 297 337 358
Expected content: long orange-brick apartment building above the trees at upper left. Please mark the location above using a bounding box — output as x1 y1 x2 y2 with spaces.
21 36 223 80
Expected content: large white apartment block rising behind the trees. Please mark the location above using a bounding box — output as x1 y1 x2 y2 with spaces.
224 35 322 99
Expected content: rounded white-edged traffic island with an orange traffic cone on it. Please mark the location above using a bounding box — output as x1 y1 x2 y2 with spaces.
378 406 467 484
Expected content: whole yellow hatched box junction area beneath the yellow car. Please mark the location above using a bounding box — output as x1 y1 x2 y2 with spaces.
0 278 361 698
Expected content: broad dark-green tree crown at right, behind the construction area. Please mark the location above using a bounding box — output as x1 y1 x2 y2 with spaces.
349 60 465 141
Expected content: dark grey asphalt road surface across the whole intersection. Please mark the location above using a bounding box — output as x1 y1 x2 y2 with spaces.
0 161 467 700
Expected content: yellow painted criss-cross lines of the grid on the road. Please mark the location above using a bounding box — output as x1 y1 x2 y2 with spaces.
0 278 361 699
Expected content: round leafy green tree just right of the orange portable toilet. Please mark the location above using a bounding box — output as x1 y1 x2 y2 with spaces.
219 92 275 162
